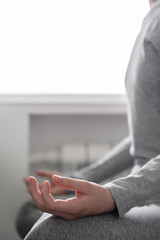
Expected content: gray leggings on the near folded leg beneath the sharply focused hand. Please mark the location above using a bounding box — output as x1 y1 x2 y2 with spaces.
25 204 160 240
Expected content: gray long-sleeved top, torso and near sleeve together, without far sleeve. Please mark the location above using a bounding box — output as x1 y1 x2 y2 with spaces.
106 1 160 216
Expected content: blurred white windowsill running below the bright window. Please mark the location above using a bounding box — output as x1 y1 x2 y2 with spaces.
0 95 126 114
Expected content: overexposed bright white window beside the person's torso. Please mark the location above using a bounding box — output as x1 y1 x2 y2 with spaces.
0 0 149 94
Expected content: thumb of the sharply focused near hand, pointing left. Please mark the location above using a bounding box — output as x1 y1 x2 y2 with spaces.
52 175 90 193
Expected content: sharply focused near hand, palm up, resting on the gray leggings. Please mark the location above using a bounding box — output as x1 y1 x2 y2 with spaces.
26 175 116 220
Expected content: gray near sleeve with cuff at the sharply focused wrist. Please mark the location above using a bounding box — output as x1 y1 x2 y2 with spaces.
105 155 160 217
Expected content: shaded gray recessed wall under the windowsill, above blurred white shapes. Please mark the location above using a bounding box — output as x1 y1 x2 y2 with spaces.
30 114 128 153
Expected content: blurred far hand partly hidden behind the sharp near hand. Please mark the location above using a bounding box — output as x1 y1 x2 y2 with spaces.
24 170 67 196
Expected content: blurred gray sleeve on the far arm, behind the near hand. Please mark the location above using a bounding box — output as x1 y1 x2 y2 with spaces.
70 137 133 183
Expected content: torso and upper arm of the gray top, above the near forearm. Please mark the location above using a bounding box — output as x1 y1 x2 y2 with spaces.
125 2 160 165
